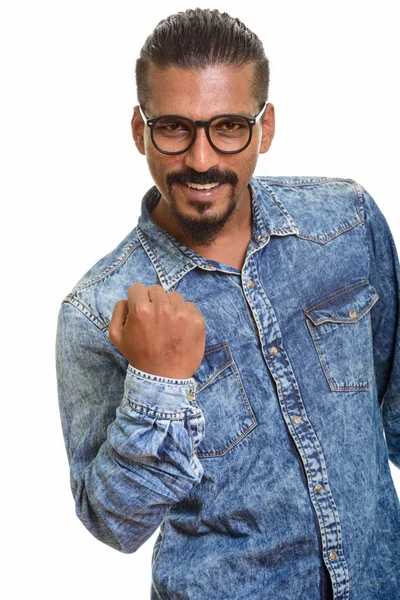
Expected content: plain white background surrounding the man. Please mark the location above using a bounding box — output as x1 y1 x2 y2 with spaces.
0 0 400 600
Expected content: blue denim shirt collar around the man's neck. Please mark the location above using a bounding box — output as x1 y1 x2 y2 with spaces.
137 177 298 291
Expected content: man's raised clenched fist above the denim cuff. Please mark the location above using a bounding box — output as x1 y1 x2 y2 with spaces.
109 282 206 379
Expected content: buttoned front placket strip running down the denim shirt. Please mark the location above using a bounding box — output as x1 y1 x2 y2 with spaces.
241 234 349 600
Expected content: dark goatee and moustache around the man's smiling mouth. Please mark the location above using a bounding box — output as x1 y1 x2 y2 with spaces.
167 169 238 246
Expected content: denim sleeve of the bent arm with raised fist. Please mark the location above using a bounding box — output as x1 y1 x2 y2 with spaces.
56 302 205 553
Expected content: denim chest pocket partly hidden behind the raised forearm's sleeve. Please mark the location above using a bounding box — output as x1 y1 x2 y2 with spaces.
193 342 257 458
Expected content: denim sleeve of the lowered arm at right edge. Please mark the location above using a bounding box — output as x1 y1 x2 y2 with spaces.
360 186 400 468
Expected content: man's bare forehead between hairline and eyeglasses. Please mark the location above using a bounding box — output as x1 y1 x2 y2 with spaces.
148 64 258 119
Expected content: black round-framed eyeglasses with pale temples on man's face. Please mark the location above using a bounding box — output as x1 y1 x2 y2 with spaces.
139 101 267 154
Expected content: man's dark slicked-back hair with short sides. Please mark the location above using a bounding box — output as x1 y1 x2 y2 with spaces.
136 8 269 108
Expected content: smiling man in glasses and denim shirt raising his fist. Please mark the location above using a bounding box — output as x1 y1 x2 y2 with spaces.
57 9 400 600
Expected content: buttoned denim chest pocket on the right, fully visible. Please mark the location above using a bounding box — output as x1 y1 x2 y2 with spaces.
304 281 379 392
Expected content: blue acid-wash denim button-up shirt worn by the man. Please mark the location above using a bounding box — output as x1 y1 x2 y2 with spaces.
57 177 400 600
